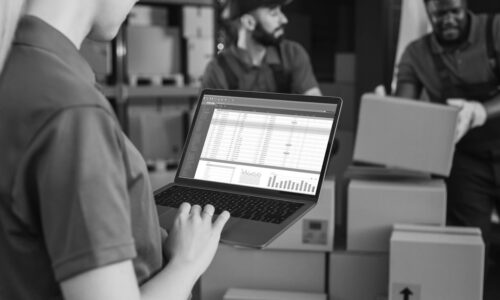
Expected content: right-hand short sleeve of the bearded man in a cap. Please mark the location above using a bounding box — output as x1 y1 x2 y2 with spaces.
289 42 318 94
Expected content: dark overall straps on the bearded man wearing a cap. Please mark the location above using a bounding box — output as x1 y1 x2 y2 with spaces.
216 46 292 94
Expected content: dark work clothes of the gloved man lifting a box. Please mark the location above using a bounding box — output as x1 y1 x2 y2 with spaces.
397 13 500 157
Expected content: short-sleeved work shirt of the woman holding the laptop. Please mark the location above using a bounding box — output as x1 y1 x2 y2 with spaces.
0 16 163 300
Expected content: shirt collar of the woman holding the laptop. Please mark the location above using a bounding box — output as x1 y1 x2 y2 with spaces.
14 15 95 84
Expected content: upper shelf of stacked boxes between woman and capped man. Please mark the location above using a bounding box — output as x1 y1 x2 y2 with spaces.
82 0 216 135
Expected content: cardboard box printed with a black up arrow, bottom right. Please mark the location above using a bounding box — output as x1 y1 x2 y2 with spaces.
389 225 484 300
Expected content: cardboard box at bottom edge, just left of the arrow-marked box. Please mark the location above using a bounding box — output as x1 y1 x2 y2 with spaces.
328 252 390 300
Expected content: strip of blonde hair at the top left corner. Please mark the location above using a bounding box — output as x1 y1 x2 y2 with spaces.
0 0 25 71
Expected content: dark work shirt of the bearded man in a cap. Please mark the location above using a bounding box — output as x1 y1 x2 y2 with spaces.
202 40 318 94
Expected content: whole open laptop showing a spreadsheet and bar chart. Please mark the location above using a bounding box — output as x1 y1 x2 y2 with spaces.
154 89 342 248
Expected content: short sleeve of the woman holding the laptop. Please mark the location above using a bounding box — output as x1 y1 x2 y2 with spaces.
36 107 136 281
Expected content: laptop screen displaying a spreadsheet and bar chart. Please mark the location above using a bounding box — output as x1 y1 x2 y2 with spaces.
178 94 337 195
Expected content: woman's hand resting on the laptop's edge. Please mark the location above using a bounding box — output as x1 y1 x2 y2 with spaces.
165 203 229 276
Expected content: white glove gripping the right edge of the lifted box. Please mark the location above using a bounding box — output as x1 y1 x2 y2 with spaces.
446 99 486 143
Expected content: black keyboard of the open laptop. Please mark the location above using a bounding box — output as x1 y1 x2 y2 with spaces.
155 186 304 224
